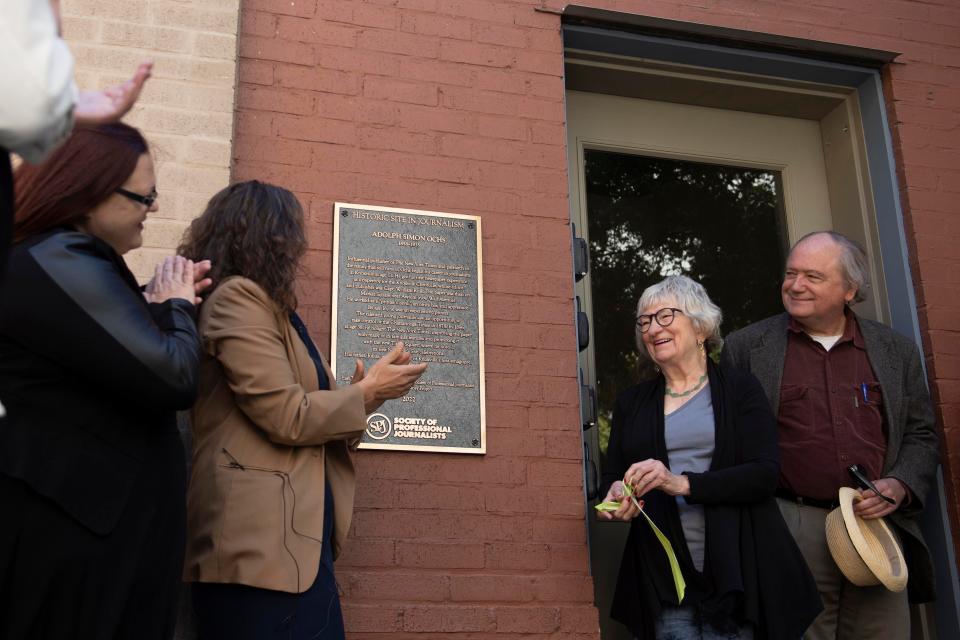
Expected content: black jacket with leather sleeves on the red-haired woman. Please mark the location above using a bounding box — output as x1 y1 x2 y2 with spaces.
0 230 200 534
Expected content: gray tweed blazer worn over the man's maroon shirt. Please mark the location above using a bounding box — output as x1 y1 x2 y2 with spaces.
721 313 940 602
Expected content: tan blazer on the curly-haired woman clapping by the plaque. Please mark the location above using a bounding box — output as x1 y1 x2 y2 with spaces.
184 277 366 593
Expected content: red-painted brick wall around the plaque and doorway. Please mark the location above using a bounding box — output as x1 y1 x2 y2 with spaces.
233 0 960 638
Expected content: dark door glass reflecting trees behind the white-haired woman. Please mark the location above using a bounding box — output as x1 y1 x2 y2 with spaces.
585 150 787 453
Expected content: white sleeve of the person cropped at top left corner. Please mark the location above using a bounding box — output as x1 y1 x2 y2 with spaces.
0 0 78 163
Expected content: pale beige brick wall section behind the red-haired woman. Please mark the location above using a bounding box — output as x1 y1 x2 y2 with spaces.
62 0 240 278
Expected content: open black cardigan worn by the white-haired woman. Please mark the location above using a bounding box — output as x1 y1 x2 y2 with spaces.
601 362 822 640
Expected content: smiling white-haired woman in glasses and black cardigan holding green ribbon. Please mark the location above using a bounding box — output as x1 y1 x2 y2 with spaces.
599 276 822 640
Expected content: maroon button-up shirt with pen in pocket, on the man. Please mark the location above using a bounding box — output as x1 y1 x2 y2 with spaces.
777 313 887 500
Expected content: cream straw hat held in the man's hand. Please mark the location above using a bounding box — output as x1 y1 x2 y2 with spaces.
826 487 907 591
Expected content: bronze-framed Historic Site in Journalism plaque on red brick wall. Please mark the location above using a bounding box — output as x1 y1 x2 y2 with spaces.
330 202 487 453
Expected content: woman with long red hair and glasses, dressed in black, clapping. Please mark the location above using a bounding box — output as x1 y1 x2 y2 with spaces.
0 124 209 640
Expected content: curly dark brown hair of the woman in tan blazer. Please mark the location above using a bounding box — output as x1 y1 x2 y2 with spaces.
177 180 307 312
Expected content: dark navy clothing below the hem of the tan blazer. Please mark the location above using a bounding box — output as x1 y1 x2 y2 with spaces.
191 562 345 640
